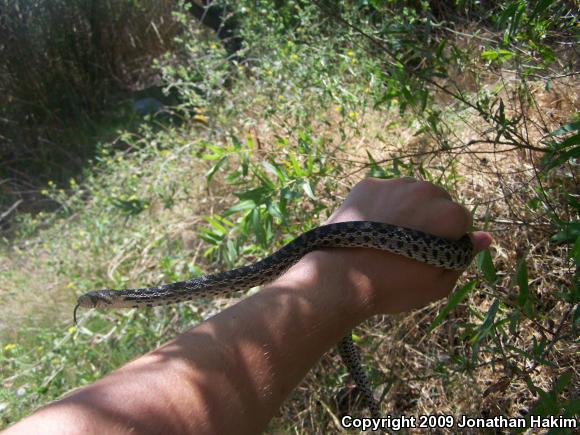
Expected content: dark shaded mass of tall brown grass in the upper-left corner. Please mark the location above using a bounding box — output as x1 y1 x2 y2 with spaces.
0 0 186 218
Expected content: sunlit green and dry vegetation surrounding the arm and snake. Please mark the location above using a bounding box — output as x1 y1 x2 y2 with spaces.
0 0 580 433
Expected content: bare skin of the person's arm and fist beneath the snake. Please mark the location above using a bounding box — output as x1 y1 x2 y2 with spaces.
5 178 491 435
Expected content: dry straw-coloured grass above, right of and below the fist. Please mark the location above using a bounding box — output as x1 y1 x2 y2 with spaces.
214 73 580 433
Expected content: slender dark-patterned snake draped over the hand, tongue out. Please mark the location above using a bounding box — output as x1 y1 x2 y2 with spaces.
73 221 473 418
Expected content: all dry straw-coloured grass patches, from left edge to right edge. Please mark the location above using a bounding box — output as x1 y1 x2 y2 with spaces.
0 11 580 433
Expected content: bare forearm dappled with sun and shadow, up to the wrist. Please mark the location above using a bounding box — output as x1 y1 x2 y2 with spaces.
3 252 368 433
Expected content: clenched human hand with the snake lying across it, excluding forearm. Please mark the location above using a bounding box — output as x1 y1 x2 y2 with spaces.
321 177 492 316
